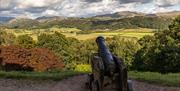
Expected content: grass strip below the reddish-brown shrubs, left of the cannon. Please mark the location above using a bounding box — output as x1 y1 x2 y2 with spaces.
0 71 87 80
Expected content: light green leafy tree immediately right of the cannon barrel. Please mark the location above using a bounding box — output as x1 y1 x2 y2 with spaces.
109 36 140 68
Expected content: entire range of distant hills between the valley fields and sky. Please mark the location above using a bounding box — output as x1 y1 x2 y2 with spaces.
1 11 180 30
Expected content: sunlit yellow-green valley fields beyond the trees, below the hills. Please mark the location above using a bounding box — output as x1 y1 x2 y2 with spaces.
3 28 154 40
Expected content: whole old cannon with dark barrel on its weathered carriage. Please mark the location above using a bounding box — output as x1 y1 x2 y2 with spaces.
87 36 132 91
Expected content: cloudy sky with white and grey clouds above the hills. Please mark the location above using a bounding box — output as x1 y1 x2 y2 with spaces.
0 0 180 18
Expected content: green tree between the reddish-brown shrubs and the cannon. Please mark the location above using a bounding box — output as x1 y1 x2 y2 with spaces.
37 32 78 69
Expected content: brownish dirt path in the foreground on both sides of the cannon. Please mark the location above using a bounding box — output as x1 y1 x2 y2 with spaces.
0 75 180 91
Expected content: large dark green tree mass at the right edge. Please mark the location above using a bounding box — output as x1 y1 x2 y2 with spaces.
134 16 180 73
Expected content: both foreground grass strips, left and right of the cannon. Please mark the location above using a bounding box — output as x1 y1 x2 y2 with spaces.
0 67 180 87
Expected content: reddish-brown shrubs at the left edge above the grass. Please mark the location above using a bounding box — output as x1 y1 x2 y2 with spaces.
0 45 64 72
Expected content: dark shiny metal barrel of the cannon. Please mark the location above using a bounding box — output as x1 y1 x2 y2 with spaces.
96 36 116 75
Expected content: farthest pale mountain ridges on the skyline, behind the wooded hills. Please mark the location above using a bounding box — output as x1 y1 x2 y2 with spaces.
0 11 180 23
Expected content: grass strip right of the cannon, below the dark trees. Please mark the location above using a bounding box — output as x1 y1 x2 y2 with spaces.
128 71 180 87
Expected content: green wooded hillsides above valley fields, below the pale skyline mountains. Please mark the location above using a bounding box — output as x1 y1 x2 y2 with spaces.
3 16 172 30
